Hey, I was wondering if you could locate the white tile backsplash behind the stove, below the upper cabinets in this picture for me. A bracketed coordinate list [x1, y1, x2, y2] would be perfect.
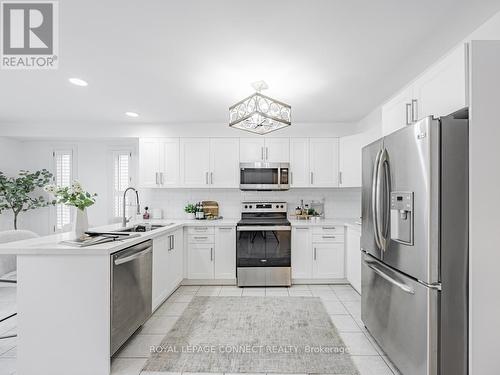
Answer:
[140, 188, 361, 219]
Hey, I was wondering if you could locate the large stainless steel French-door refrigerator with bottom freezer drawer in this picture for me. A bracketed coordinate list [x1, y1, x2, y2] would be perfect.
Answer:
[361, 109, 469, 375]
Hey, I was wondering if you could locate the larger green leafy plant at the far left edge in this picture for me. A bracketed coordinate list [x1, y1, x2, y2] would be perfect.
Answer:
[0, 169, 55, 229]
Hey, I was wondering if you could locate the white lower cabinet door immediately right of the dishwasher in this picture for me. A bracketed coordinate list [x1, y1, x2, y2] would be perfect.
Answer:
[152, 235, 170, 310]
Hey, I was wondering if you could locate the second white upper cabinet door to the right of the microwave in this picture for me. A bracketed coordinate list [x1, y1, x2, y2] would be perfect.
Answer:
[309, 138, 339, 187]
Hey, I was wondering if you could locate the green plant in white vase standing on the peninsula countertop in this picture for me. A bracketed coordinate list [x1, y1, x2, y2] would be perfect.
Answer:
[44, 180, 97, 238]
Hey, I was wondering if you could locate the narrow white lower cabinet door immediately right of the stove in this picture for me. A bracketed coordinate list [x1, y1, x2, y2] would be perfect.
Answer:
[292, 227, 313, 279]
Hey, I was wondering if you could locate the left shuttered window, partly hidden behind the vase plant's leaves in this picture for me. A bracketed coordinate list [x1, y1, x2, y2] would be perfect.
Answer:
[53, 150, 73, 232]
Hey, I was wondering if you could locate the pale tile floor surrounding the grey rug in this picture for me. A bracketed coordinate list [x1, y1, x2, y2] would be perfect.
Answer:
[0, 285, 399, 375]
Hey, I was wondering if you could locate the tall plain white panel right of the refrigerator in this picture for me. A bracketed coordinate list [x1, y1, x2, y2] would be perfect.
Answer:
[469, 39, 500, 374]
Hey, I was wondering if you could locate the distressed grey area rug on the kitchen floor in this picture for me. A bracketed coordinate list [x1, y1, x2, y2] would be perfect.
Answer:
[143, 297, 359, 375]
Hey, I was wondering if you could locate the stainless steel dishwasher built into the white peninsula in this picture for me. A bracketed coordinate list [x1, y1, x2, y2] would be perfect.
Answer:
[111, 240, 153, 355]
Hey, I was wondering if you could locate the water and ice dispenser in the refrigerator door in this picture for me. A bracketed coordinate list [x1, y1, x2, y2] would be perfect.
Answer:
[391, 191, 413, 245]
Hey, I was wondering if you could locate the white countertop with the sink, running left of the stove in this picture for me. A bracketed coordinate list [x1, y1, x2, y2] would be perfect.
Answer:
[0, 219, 239, 255]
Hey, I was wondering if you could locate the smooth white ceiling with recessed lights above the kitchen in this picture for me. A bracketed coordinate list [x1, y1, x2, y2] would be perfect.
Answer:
[0, 0, 500, 129]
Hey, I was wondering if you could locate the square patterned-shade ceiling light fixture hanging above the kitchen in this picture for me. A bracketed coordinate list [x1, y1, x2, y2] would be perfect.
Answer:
[229, 81, 292, 135]
